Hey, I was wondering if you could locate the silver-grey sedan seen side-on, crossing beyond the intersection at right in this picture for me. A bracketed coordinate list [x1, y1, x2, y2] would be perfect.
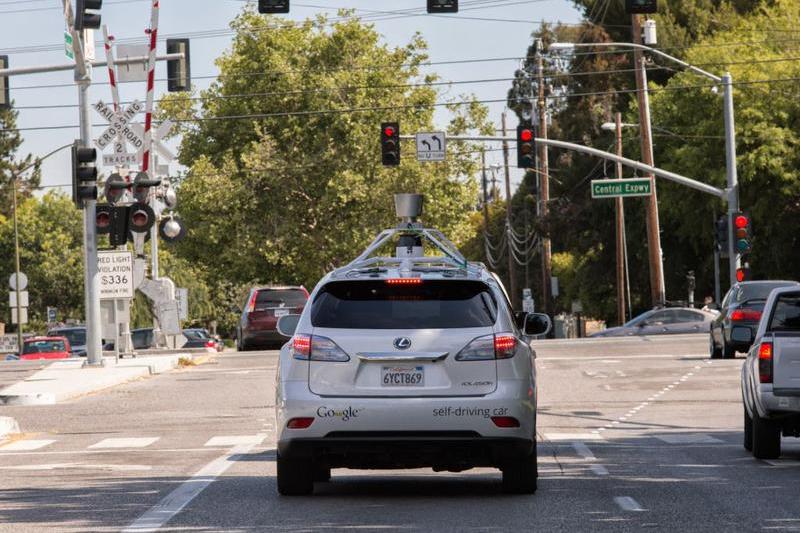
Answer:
[591, 307, 717, 337]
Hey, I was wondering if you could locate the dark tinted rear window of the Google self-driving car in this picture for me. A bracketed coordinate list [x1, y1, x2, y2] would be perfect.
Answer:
[311, 280, 497, 329]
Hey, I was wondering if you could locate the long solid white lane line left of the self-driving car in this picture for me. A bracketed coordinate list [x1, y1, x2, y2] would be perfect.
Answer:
[122, 435, 266, 533]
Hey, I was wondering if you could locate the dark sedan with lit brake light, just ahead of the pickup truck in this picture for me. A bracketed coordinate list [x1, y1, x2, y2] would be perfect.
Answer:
[709, 281, 798, 359]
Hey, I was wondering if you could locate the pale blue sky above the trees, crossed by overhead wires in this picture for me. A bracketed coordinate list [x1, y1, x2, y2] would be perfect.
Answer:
[0, 0, 580, 193]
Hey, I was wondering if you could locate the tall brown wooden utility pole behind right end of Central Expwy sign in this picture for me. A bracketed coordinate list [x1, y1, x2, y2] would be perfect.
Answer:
[631, 15, 666, 307]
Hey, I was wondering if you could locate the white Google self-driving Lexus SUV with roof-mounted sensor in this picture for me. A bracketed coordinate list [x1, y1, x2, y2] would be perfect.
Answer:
[276, 195, 550, 495]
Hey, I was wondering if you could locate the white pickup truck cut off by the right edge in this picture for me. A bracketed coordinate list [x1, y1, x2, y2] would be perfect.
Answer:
[742, 287, 800, 459]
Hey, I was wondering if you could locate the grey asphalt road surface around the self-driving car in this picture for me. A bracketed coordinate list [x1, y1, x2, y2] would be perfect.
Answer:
[0, 336, 800, 532]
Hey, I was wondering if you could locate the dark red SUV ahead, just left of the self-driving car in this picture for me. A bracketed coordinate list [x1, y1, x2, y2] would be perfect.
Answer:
[236, 286, 308, 351]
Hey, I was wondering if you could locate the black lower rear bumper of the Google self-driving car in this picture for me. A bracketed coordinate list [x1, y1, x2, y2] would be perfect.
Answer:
[278, 431, 534, 471]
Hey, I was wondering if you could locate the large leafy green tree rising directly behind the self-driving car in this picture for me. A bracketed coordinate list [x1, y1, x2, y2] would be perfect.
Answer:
[163, 8, 491, 287]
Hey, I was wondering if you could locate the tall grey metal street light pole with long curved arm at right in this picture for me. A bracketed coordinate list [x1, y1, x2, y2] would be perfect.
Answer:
[550, 43, 741, 285]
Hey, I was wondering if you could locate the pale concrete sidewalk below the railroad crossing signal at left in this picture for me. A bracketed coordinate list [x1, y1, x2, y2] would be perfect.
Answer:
[0, 353, 214, 405]
